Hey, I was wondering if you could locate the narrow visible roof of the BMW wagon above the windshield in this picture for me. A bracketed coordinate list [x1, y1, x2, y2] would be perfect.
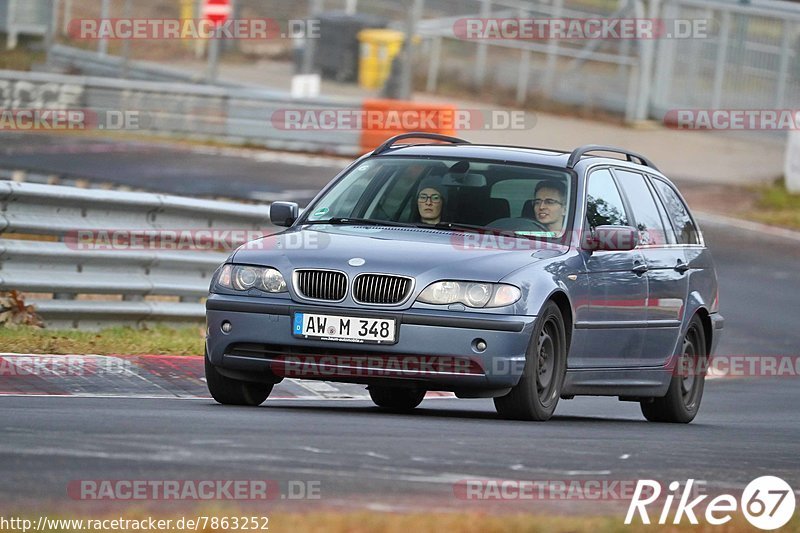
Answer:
[374, 143, 663, 176]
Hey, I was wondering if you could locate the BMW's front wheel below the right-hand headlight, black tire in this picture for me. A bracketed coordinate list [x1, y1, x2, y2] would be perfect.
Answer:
[494, 301, 567, 422]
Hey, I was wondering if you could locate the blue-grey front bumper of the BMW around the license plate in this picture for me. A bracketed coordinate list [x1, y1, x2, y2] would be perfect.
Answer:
[206, 294, 536, 392]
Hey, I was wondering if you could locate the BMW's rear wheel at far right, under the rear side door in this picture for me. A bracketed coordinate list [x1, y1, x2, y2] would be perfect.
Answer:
[640, 315, 708, 424]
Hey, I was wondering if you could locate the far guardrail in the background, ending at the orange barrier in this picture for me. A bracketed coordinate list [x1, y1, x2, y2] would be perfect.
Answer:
[0, 71, 363, 156]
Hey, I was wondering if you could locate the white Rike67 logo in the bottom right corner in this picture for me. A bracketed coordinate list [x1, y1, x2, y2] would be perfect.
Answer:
[625, 476, 796, 530]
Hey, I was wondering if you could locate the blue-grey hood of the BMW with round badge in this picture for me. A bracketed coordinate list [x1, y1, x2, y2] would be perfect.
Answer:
[233, 225, 568, 281]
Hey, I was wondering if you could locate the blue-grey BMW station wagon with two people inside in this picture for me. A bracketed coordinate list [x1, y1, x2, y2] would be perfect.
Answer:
[206, 133, 724, 423]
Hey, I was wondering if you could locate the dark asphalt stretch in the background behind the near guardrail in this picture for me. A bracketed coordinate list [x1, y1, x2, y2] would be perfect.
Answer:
[0, 133, 348, 203]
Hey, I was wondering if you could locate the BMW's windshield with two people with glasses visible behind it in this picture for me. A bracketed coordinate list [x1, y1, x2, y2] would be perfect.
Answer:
[301, 157, 573, 238]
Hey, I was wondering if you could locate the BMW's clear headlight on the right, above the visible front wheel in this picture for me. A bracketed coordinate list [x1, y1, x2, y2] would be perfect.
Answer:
[417, 281, 522, 307]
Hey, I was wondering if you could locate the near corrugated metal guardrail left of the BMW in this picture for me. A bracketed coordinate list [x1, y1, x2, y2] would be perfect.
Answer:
[0, 181, 274, 328]
